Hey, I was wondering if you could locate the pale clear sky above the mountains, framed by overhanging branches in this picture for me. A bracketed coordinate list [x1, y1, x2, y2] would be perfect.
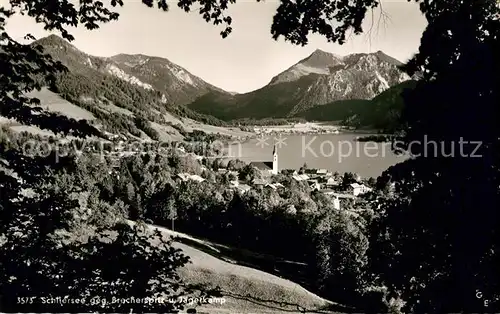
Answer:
[0, 0, 427, 93]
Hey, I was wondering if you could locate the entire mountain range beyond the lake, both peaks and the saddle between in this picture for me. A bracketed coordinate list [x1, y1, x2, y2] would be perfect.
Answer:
[1, 35, 410, 139]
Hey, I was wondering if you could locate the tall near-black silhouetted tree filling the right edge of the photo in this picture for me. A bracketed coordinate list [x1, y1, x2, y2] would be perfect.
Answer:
[370, 1, 500, 312]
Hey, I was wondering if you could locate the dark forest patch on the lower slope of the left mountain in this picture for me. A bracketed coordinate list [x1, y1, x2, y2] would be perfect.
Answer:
[50, 72, 226, 140]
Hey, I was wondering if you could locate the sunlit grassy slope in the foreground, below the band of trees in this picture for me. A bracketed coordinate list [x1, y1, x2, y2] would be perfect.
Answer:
[135, 221, 345, 313]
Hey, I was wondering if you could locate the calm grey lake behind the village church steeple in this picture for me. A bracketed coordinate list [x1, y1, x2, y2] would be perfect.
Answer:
[226, 133, 406, 177]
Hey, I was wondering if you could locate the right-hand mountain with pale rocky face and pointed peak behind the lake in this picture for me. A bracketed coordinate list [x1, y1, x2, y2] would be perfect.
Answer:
[188, 50, 410, 120]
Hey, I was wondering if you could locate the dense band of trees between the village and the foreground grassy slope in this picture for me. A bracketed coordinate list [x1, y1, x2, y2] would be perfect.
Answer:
[3, 130, 382, 312]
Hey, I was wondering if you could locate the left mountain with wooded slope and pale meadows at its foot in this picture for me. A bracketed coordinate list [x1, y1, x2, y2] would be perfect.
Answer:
[16, 35, 244, 140]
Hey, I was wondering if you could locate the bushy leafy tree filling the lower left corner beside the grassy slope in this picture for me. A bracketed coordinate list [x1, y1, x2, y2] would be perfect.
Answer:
[0, 143, 208, 312]
